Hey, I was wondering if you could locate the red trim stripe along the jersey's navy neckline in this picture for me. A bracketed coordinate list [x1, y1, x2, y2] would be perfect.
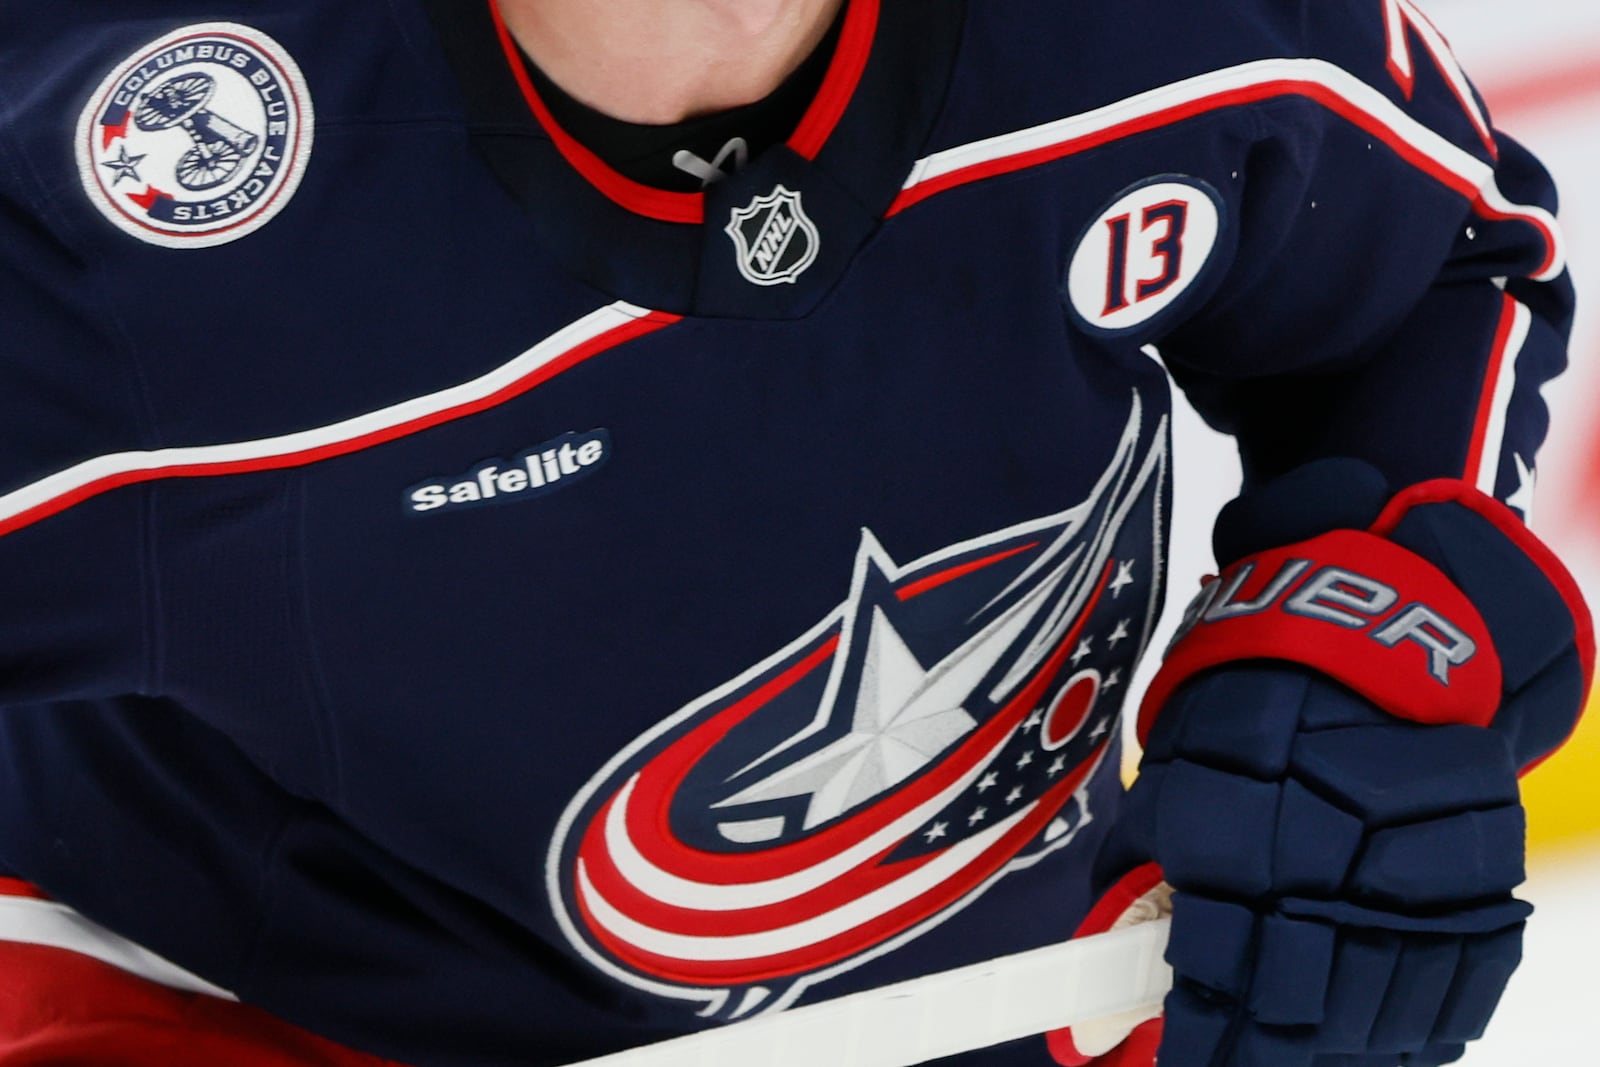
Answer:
[488, 0, 880, 224]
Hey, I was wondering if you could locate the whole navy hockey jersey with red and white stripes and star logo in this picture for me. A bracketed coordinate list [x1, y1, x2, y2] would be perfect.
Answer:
[0, 0, 1570, 1067]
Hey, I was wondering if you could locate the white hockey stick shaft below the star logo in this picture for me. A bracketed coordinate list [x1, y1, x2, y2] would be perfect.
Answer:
[571, 918, 1173, 1067]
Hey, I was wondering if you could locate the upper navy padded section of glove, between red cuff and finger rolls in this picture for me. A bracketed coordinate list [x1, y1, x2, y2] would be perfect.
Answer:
[1128, 664, 1525, 920]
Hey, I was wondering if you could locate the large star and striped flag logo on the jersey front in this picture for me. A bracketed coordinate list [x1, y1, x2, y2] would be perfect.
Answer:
[547, 391, 1166, 1019]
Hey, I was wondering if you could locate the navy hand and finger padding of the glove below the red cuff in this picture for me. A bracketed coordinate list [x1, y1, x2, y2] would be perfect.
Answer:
[1132, 664, 1531, 1067]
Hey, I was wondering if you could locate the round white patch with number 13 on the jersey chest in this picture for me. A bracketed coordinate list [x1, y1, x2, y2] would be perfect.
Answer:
[1066, 174, 1222, 331]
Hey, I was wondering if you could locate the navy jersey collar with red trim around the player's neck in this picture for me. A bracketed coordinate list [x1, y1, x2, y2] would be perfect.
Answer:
[422, 0, 965, 318]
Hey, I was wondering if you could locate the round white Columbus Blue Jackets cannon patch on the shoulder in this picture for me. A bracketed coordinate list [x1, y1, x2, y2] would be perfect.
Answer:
[77, 22, 314, 248]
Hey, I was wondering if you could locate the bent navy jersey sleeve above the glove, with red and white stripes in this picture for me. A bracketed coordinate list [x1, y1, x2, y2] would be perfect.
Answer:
[1160, 0, 1573, 512]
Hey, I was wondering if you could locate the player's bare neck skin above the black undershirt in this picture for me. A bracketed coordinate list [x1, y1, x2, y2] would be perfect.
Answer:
[499, 0, 845, 125]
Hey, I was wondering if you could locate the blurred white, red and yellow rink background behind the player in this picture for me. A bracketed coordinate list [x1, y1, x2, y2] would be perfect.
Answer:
[1146, 0, 1600, 1067]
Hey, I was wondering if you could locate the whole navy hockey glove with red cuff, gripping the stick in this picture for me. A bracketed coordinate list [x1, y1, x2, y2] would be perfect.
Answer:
[1053, 462, 1594, 1067]
